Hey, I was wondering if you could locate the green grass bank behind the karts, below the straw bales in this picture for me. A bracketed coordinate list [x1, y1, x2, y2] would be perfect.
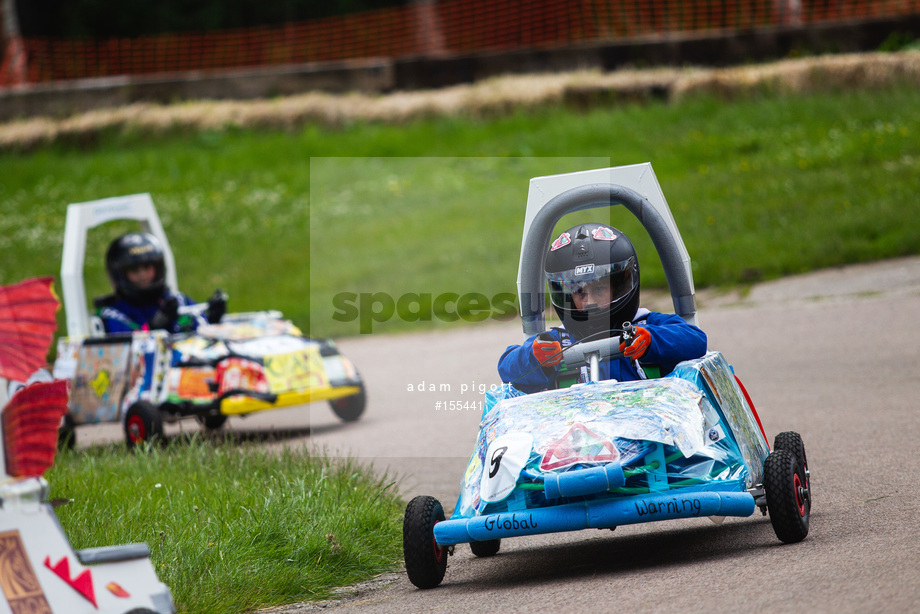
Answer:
[0, 85, 920, 336]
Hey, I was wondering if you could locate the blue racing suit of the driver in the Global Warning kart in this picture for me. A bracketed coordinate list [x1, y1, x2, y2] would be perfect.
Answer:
[498, 309, 706, 394]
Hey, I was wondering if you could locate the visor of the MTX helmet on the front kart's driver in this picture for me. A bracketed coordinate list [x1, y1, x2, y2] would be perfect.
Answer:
[546, 258, 639, 309]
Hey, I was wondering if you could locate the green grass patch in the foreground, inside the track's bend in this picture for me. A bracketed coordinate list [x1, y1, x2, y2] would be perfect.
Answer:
[46, 439, 403, 614]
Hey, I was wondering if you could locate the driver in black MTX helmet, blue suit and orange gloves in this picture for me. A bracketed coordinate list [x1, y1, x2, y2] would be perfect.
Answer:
[498, 224, 706, 393]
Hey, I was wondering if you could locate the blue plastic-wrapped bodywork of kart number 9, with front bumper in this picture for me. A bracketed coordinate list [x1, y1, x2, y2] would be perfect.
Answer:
[434, 352, 769, 545]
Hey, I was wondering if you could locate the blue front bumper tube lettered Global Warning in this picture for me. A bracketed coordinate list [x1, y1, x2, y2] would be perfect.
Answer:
[434, 489, 756, 546]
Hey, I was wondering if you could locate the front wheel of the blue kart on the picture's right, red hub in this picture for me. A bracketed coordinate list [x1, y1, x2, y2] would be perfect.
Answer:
[763, 449, 811, 544]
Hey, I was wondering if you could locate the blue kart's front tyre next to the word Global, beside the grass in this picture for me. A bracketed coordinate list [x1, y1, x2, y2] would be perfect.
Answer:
[403, 495, 447, 588]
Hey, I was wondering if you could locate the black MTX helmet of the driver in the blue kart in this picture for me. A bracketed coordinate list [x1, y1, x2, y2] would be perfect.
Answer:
[543, 223, 639, 339]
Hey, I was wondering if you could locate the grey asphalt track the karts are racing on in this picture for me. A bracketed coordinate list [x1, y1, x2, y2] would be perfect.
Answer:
[78, 258, 920, 614]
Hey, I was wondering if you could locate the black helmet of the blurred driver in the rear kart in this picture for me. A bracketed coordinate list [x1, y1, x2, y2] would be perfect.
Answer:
[105, 232, 166, 303]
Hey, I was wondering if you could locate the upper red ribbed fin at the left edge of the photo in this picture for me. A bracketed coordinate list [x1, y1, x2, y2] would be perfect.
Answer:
[0, 277, 58, 382]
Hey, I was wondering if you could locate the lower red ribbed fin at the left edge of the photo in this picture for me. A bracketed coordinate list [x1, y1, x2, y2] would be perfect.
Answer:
[2, 379, 70, 478]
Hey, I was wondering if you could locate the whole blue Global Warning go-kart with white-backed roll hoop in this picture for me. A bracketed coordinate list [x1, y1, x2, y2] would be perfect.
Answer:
[403, 164, 811, 588]
